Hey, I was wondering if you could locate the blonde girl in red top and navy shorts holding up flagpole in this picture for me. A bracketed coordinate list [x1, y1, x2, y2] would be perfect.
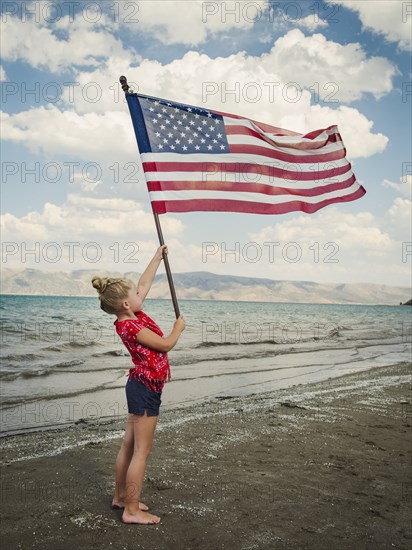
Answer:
[92, 245, 185, 524]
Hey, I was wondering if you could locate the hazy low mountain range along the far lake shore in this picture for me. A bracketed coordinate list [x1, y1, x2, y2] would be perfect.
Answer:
[0, 269, 411, 305]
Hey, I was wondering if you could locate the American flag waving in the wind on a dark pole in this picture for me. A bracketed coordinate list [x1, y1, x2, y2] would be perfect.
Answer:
[126, 93, 366, 214]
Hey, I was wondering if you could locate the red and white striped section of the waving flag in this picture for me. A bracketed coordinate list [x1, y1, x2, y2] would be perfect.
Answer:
[141, 113, 366, 214]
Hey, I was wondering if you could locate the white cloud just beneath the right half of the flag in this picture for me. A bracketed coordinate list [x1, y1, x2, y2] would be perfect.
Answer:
[232, 205, 406, 283]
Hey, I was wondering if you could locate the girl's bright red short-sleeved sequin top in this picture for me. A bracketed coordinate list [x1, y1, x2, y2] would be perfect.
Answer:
[114, 311, 170, 393]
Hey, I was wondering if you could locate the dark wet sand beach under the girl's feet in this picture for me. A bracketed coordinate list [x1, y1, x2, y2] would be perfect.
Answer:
[1, 363, 412, 550]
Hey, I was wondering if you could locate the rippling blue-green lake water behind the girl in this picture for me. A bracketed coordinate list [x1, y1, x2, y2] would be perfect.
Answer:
[0, 295, 412, 435]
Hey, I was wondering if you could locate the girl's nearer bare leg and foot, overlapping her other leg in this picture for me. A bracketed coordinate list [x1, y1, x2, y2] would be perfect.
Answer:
[122, 411, 160, 524]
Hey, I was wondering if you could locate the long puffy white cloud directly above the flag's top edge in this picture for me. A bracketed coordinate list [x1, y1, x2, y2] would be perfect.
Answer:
[64, 29, 397, 117]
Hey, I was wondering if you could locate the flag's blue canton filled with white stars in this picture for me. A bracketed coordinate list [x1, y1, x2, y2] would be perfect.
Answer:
[139, 97, 229, 154]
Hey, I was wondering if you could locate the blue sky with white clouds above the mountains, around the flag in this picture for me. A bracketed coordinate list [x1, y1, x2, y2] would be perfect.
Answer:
[0, 0, 412, 286]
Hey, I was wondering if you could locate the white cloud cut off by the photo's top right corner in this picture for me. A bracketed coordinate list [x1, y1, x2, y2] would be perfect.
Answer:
[337, 0, 412, 50]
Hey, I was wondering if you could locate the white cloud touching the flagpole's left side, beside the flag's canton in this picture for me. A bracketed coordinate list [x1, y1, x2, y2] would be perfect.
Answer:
[0, 105, 159, 204]
